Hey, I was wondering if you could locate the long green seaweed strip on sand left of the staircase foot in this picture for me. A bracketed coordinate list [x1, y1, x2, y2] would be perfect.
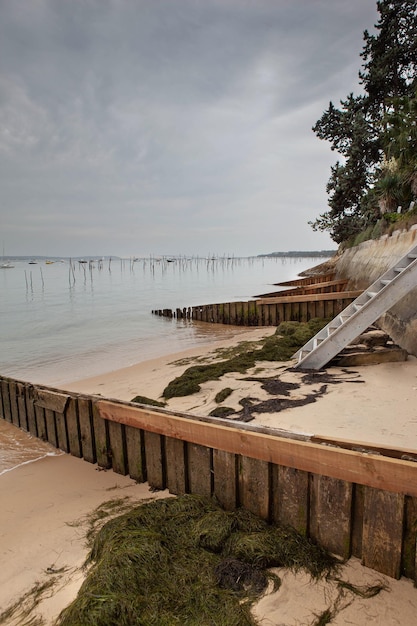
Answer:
[162, 318, 329, 400]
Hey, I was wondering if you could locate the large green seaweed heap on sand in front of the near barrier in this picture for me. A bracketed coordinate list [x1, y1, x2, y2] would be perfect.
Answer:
[57, 495, 338, 626]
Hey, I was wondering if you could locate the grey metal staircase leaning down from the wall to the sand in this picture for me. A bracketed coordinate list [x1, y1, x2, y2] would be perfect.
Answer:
[293, 245, 417, 370]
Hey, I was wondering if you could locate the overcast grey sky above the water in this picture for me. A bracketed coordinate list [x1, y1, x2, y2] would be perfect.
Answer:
[0, 0, 378, 256]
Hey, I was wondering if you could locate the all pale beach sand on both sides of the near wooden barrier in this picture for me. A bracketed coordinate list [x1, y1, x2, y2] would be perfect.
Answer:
[0, 328, 417, 626]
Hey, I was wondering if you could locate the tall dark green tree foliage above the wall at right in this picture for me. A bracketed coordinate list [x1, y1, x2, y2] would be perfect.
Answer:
[311, 0, 417, 243]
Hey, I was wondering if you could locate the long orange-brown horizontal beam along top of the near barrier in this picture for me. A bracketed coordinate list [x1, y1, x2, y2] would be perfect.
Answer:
[97, 400, 417, 496]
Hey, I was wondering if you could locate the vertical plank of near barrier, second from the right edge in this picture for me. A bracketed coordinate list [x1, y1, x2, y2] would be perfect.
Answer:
[362, 487, 404, 578]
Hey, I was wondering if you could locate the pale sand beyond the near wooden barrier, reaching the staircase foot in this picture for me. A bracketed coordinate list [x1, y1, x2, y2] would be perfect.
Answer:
[63, 327, 417, 452]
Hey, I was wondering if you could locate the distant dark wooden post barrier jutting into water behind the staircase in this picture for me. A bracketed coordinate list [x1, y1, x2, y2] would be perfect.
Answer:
[152, 291, 362, 326]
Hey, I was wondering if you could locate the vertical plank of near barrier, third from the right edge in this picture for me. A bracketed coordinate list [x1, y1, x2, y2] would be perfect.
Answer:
[310, 474, 352, 559]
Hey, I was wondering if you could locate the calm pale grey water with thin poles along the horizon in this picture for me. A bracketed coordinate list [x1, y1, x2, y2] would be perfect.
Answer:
[0, 258, 323, 386]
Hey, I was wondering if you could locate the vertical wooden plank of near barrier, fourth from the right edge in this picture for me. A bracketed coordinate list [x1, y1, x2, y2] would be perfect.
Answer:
[272, 465, 309, 535]
